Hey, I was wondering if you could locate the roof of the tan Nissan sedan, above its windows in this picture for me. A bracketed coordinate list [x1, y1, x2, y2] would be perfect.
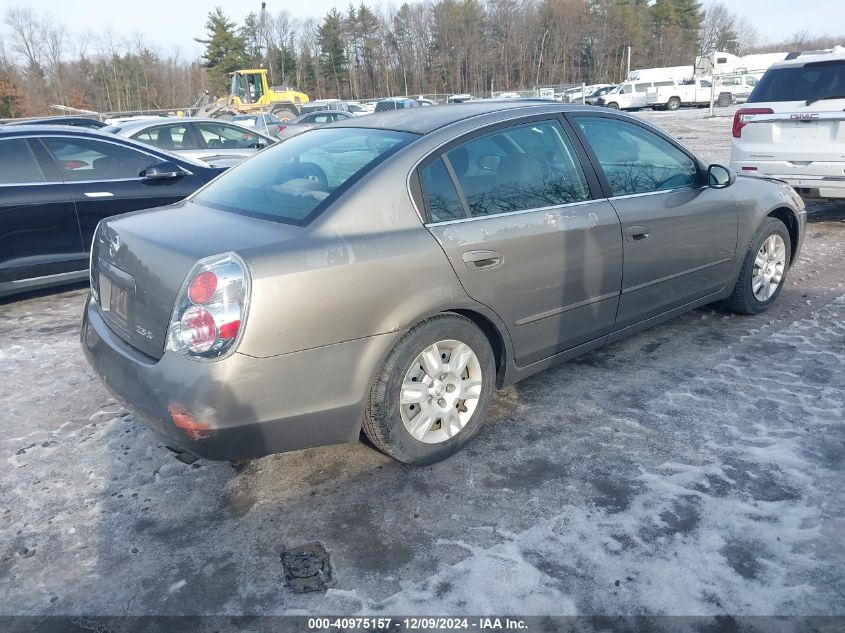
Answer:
[326, 99, 596, 134]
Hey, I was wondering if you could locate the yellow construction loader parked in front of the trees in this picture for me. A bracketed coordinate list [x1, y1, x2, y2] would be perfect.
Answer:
[196, 68, 309, 121]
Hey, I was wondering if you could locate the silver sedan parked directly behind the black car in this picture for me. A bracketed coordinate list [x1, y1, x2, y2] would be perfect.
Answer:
[102, 117, 276, 164]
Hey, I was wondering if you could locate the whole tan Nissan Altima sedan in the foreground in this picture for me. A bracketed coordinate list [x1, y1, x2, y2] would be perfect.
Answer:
[82, 101, 805, 464]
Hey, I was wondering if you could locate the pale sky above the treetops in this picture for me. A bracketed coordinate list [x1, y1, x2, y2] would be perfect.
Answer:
[0, 0, 845, 59]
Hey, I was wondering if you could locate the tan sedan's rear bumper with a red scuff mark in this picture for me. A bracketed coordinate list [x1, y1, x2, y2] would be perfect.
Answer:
[81, 300, 395, 460]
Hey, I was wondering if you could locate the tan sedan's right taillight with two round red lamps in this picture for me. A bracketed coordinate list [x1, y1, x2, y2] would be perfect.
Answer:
[166, 253, 250, 358]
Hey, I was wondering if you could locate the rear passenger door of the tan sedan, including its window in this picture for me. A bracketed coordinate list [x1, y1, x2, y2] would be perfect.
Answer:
[418, 118, 622, 366]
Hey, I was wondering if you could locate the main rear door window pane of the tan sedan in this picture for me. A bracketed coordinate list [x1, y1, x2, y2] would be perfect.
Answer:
[436, 121, 590, 216]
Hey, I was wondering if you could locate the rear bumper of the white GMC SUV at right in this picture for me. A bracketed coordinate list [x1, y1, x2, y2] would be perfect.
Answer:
[731, 159, 845, 198]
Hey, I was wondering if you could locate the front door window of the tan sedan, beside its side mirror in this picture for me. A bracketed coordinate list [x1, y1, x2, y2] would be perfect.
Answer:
[575, 117, 698, 196]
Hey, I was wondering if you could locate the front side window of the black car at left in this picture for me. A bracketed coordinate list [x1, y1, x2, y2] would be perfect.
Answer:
[43, 137, 161, 181]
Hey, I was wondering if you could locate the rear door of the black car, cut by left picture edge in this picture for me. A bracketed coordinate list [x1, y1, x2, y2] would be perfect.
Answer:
[0, 138, 88, 282]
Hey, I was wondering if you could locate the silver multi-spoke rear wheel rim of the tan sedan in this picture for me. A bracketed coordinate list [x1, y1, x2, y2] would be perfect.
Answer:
[399, 339, 481, 444]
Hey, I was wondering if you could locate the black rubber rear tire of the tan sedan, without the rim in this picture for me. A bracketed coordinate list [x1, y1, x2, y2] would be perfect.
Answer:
[363, 314, 496, 465]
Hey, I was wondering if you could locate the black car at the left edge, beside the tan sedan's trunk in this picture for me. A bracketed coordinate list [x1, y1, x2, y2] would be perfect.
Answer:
[0, 125, 224, 297]
